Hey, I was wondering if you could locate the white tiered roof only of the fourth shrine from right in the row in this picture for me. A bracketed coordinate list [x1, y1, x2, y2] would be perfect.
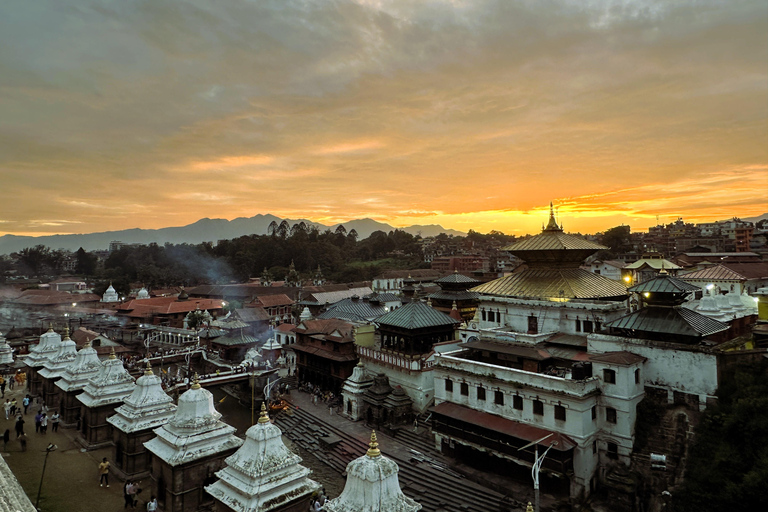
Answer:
[107, 362, 176, 433]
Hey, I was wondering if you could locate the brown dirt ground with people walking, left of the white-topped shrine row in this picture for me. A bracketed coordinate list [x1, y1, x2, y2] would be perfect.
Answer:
[0, 388, 138, 512]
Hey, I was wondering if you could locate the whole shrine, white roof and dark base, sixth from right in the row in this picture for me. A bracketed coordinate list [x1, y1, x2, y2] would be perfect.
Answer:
[55, 341, 101, 428]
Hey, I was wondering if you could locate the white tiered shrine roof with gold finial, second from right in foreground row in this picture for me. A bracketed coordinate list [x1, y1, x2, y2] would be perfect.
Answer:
[205, 403, 320, 512]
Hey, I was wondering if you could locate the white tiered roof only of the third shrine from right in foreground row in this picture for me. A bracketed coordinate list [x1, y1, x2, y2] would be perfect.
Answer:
[144, 376, 243, 466]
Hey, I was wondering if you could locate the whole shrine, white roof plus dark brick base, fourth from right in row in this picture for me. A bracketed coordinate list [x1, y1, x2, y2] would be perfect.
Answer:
[107, 362, 176, 480]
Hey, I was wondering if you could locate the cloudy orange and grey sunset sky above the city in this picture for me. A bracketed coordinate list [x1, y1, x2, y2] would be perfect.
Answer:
[0, 0, 768, 235]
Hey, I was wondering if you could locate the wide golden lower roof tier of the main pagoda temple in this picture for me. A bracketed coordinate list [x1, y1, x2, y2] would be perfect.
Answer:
[471, 268, 627, 299]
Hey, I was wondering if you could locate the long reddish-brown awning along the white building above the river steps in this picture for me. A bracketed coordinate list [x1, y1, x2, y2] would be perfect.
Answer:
[430, 402, 576, 452]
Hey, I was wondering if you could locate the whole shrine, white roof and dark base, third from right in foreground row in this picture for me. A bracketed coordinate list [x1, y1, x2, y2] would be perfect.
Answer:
[144, 376, 243, 512]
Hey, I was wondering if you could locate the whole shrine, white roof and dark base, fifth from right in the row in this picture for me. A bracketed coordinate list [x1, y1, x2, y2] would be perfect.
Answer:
[76, 349, 136, 450]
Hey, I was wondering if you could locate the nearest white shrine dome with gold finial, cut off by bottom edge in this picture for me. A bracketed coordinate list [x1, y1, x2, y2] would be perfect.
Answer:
[323, 432, 421, 512]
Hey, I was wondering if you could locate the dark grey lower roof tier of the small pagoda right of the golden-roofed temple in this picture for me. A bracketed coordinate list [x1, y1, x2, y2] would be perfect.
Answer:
[606, 307, 728, 338]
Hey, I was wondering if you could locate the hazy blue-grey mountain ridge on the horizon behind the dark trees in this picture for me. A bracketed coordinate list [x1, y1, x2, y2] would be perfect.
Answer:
[0, 214, 466, 254]
